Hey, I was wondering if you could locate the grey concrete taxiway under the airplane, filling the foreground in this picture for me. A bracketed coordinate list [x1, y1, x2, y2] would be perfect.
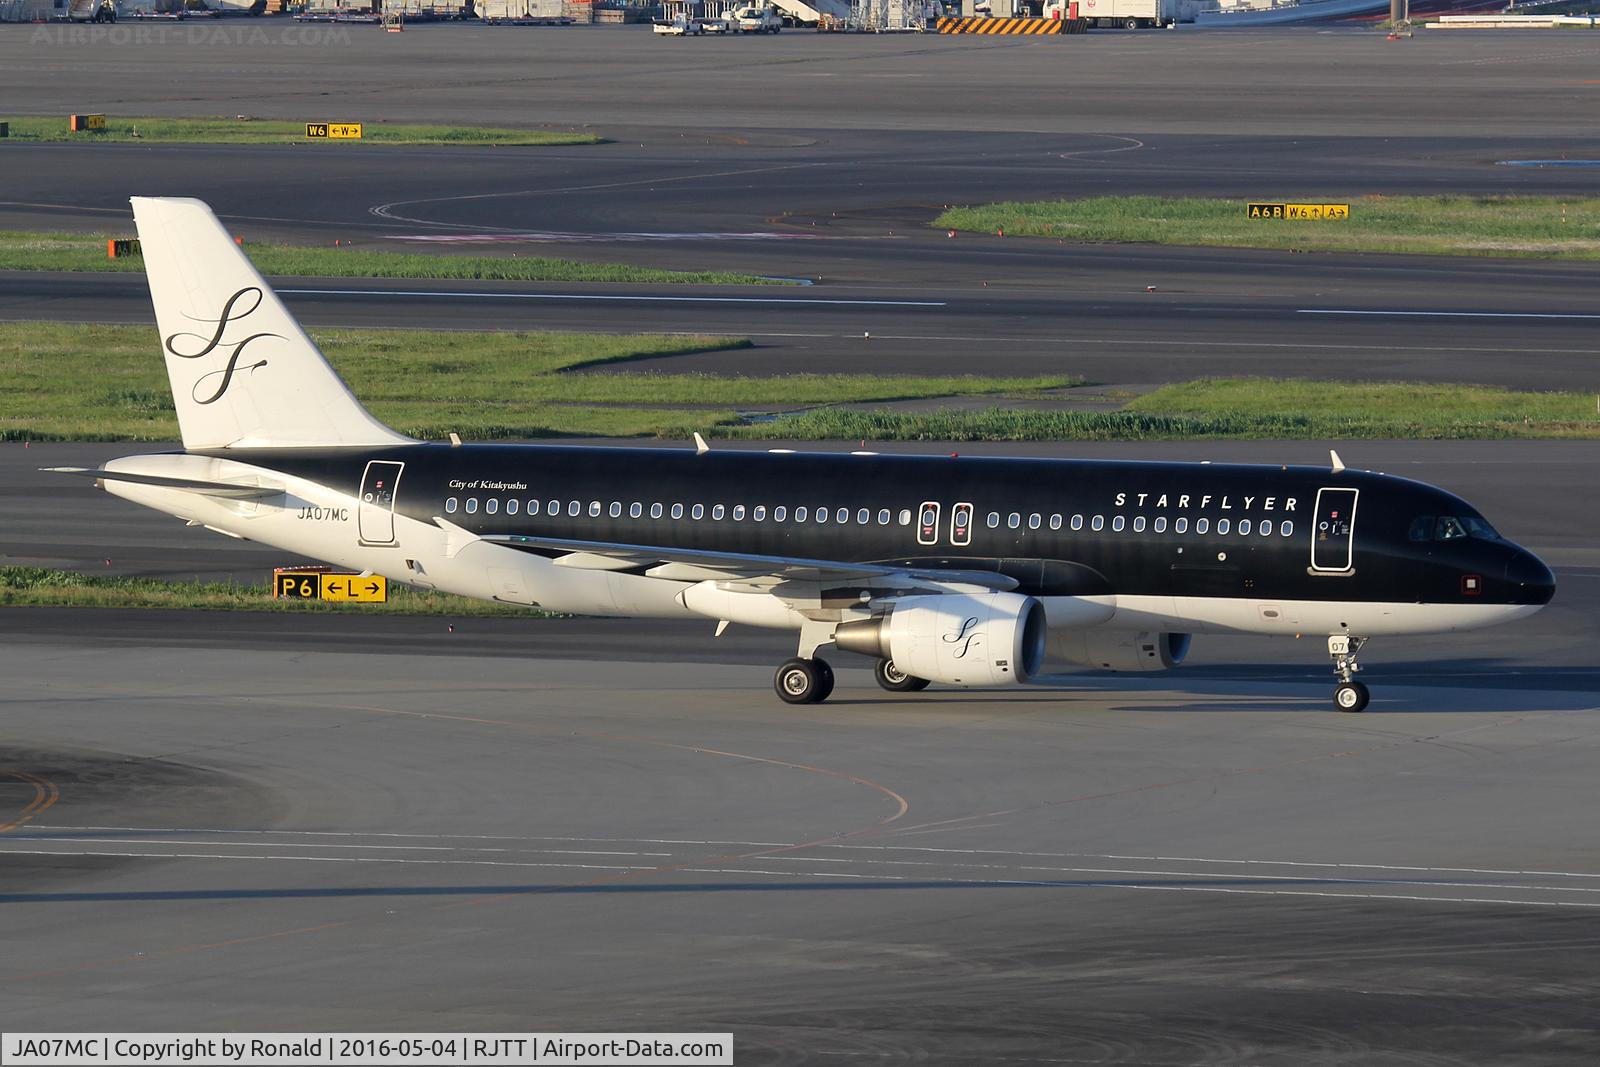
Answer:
[0, 442, 1600, 1064]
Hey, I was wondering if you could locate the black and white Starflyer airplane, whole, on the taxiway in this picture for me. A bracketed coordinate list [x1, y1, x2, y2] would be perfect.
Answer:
[53, 197, 1555, 712]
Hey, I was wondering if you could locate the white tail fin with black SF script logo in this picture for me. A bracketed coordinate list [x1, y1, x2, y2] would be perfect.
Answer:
[133, 197, 411, 448]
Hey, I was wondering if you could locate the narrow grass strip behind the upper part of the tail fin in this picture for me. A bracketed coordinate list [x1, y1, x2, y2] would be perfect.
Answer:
[0, 226, 789, 285]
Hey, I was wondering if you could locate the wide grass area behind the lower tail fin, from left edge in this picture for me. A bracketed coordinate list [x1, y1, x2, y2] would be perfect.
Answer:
[0, 323, 1080, 442]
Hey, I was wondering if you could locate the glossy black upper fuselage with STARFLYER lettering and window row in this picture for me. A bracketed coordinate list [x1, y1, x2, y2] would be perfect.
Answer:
[213, 445, 1554, 605]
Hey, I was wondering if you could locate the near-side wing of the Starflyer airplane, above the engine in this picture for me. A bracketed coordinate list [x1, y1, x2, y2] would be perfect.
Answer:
[476, 534, 1018, 590]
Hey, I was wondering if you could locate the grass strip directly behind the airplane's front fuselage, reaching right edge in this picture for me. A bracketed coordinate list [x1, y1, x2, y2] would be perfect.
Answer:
[732, 378, 1600, 442]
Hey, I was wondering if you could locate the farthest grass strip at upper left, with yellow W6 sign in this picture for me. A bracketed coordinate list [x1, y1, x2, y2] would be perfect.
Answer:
[0, 115, 602, 150]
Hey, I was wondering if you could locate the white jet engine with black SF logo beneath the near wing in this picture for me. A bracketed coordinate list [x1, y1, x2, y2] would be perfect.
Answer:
[834, 593, 1045, 685]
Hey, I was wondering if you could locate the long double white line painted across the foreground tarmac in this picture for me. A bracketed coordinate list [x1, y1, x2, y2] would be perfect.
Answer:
[15, 825, 1600, 907]
